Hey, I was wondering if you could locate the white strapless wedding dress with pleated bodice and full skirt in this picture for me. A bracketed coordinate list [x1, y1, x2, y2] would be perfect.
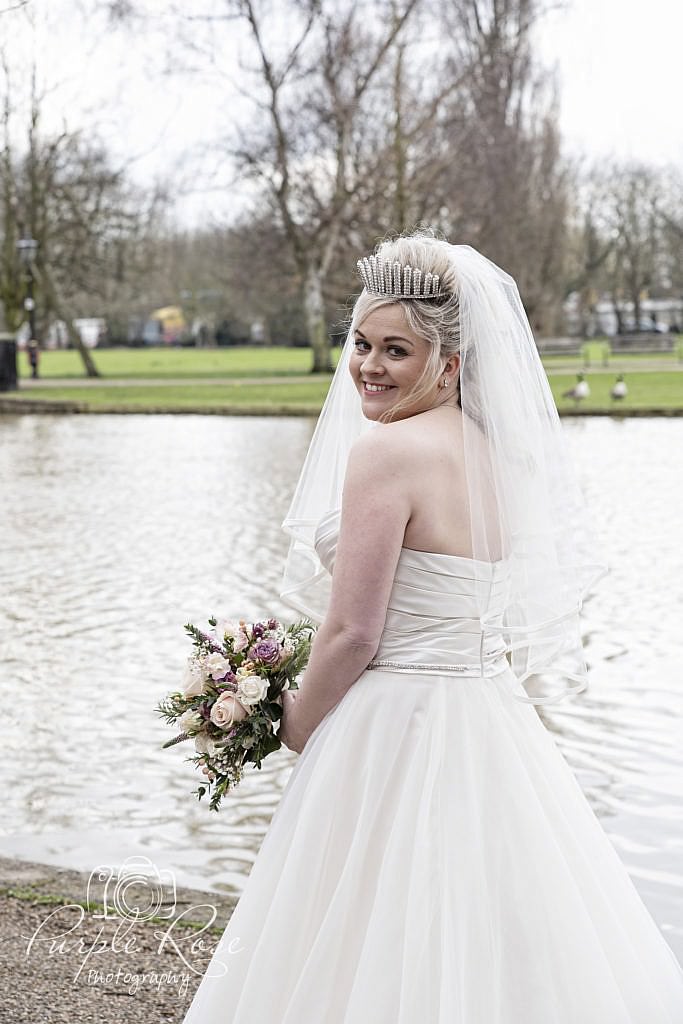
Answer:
[185, 511, 683, 1024]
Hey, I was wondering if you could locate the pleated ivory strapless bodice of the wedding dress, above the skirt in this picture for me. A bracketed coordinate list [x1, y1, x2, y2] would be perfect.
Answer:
[315, 509, 509, 677]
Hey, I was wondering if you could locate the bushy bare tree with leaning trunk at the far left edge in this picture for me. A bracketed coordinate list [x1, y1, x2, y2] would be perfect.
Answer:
[0, 50, 163, 377]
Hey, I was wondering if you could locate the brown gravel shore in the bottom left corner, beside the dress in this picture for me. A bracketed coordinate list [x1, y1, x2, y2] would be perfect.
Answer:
[0, 858, 240, 1024]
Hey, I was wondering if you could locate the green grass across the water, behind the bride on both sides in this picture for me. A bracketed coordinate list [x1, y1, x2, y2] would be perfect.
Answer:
[6, 348, 683, 416]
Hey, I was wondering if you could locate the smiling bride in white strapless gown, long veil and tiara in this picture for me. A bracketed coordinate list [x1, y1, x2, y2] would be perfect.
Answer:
[185, 232, 683, 1024]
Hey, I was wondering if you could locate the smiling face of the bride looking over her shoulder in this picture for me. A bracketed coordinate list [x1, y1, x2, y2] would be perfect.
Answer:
[349, 304, 446, 420]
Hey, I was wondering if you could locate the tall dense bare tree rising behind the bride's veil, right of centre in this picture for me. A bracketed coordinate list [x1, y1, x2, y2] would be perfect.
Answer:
[421, 0, 570, 331]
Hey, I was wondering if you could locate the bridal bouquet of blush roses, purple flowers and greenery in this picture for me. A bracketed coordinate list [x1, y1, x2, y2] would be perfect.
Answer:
[155, 617, 315, 811]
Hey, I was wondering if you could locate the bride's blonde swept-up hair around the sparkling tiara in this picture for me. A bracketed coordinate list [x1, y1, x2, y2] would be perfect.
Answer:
[351, 231, 460, 422]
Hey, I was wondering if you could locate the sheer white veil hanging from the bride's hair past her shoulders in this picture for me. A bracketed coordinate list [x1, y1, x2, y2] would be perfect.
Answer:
[281, 240, 607, 705]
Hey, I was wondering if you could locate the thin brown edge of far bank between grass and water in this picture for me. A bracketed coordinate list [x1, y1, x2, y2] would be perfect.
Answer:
[0, 395, 683, 420]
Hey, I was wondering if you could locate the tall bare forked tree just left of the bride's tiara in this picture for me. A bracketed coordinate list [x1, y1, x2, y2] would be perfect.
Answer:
[156, 0, 418, 373]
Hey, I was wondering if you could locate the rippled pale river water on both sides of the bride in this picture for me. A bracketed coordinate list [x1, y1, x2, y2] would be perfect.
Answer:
[0, 416, 683, 958]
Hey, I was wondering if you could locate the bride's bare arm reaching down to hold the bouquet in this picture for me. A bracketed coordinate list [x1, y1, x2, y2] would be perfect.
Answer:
[282, 427, 411, 752]
